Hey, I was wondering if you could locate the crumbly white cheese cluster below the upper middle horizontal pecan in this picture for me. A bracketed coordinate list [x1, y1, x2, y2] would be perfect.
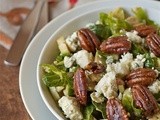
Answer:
[106, 53, 133, 75]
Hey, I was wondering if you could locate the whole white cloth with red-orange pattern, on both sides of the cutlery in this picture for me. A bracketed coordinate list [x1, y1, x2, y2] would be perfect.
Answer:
[0, 0, 94, 49]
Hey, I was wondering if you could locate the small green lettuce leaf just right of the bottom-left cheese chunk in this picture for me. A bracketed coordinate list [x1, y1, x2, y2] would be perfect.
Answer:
[83, 104, 95, 120]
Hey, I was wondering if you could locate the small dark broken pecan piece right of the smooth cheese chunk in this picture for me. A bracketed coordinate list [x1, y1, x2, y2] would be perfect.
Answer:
[85, 62, 105, 74]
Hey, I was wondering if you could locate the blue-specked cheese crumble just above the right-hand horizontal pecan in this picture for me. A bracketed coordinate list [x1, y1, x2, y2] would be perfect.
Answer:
[131, 54, 146, 70]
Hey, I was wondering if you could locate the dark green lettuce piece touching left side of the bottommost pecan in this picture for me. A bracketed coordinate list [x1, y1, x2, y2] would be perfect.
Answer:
[92, 101, 107, 119]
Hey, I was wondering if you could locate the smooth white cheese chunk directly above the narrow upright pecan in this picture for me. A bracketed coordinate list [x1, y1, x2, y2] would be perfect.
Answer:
[73, 50, 93, 68]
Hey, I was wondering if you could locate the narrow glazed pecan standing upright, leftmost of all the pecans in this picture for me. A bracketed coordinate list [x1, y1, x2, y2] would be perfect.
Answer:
[73, 68, 87, 105]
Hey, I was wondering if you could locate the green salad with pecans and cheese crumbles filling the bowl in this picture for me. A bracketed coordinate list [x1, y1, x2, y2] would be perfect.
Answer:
[41, 7, 160, 120]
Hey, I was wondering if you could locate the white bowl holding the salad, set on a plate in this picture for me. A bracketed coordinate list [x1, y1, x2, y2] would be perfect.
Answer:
[37, 0, 160, 119]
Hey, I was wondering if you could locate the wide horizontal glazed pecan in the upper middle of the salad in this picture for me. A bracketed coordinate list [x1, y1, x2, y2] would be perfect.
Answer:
[100, 36, 131, 54]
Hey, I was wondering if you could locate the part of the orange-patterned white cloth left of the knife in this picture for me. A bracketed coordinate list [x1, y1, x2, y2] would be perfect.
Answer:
[0, 0, 35, 49]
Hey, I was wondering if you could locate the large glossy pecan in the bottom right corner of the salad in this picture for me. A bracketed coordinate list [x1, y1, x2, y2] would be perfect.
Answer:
[131, 85, 159, 116]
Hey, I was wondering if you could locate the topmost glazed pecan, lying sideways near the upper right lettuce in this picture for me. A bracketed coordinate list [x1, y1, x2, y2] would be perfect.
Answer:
[135, 24, 156, 37]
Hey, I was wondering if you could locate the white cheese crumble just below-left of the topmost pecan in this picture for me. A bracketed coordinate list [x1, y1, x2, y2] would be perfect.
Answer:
[126, 30, 144, 43]
